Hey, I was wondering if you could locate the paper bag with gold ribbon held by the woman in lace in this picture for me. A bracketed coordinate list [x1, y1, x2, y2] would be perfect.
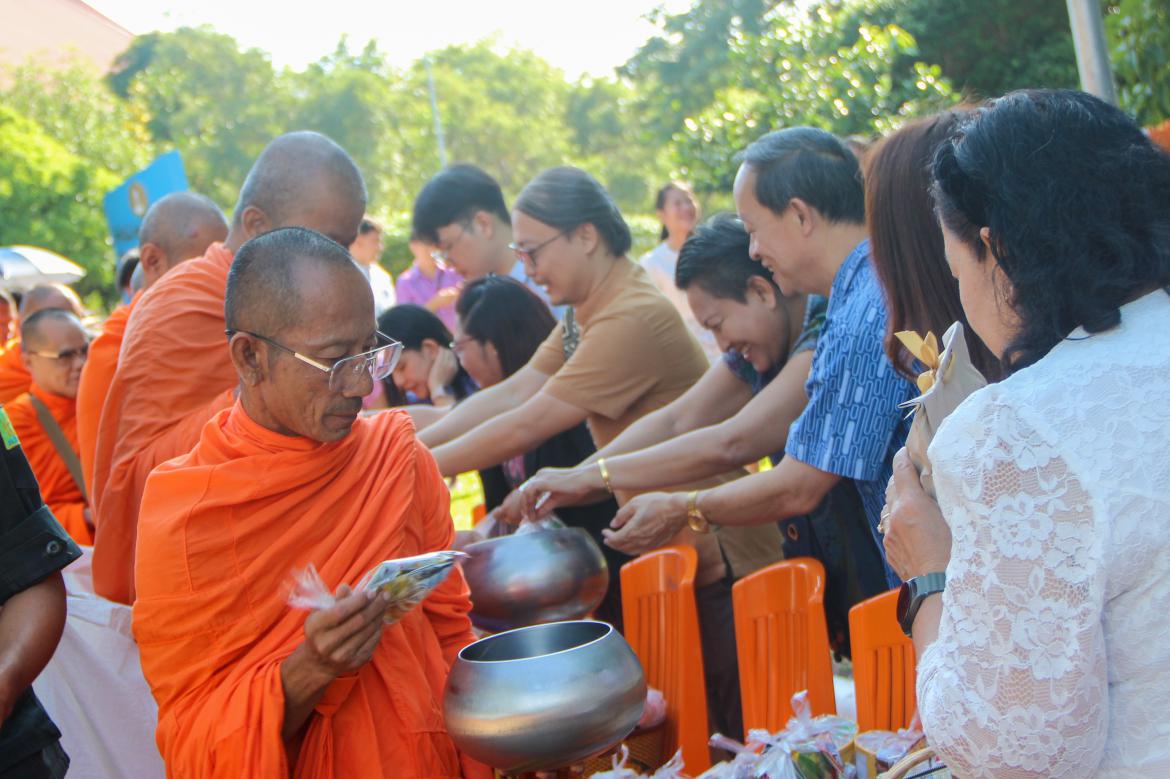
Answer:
[895, 322, 987, 497]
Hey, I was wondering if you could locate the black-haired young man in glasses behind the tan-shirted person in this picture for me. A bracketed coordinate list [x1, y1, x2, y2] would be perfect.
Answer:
[412, 163, 565, 319]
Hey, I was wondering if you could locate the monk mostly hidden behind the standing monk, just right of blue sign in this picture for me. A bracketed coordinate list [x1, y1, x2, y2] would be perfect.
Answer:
[77, 192, 227, 488]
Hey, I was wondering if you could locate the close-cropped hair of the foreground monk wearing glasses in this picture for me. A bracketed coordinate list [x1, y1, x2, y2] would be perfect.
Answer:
[223, 227, 360, 336]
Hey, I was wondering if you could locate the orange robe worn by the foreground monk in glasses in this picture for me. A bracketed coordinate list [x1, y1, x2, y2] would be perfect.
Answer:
[133, 404, 490, 779]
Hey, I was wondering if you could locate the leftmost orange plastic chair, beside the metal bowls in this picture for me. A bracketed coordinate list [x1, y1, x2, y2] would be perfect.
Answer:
[621, 546, 711, 775]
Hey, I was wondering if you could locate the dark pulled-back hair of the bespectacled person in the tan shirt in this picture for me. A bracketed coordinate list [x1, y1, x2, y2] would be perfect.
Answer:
[515, 166, 633, 257]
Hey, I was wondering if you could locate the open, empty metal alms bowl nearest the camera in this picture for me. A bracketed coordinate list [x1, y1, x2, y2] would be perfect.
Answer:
[443, 620, 646, 773]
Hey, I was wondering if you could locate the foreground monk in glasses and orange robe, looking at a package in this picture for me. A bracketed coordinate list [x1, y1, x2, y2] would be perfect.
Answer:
[133, 228, 490, 779]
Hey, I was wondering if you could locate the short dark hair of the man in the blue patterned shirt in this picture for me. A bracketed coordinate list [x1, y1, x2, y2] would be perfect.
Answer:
[738, 127, 866, 223]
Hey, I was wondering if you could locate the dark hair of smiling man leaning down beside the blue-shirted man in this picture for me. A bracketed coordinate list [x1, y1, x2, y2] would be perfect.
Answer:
[674, 214, 782, 303]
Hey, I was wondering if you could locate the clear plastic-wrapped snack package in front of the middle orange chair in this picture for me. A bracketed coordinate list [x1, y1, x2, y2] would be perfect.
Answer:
[748, 690, 858, 779]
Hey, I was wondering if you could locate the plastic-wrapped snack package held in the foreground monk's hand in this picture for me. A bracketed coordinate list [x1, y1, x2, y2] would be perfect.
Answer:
[288, 551, 467, 625]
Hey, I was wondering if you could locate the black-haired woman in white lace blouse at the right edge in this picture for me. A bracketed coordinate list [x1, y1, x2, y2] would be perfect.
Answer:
[886, 91, 1170, 778]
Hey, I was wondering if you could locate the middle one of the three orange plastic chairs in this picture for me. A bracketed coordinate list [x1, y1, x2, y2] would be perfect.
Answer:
[731, 557, 837, 732]
